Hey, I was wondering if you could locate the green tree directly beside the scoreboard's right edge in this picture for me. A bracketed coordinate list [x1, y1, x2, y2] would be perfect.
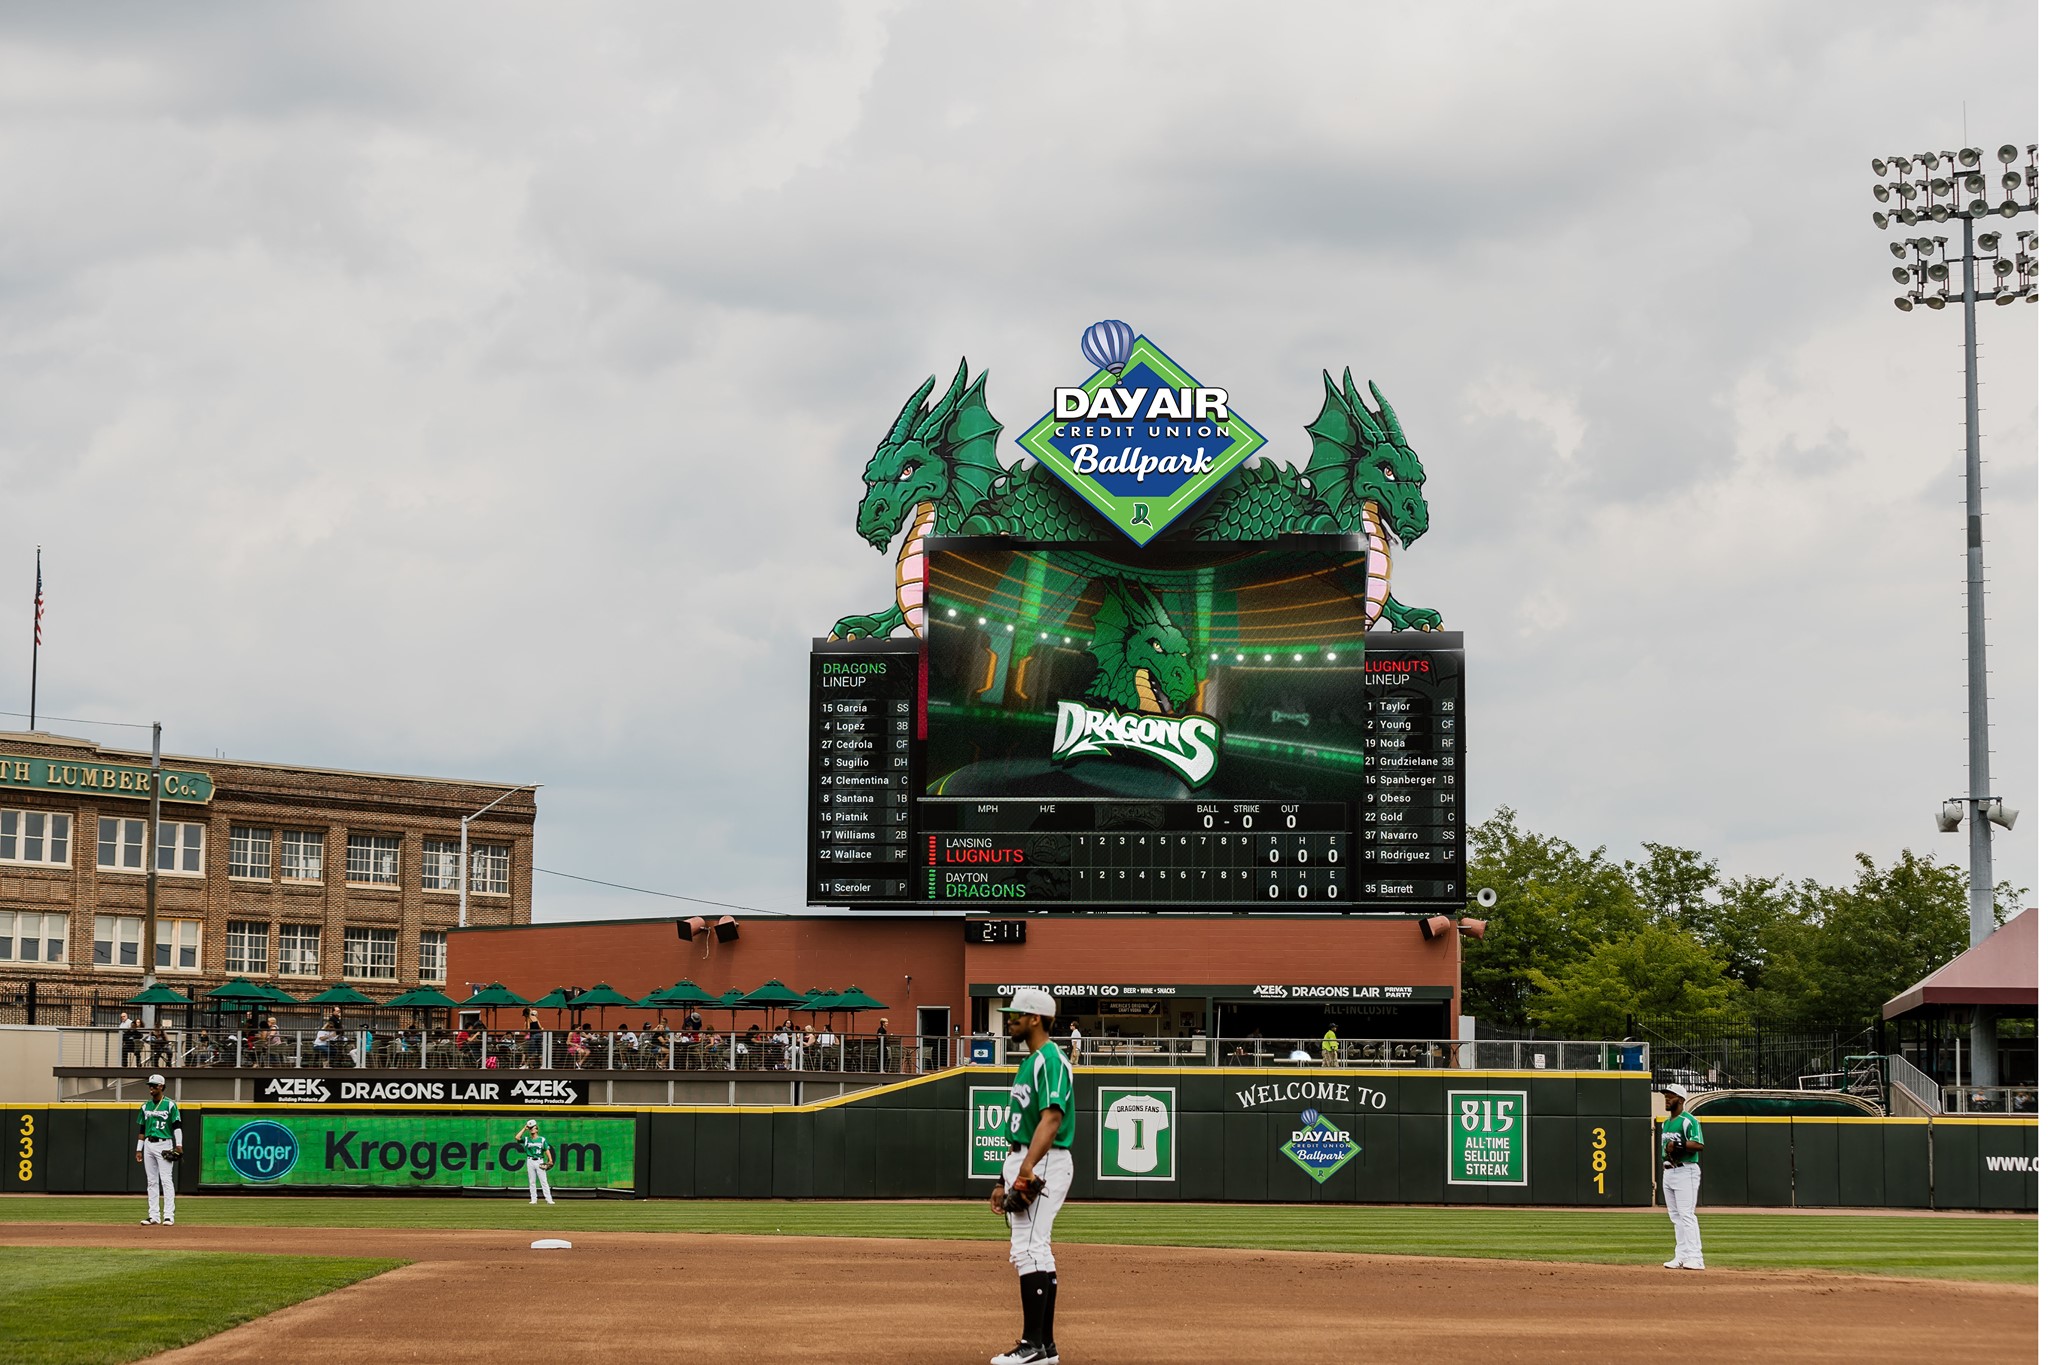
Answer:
[1464, 806, 1645, 1027]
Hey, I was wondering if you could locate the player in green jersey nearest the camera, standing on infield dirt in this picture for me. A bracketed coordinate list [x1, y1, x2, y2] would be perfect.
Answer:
[989, 986, 1073, 1365]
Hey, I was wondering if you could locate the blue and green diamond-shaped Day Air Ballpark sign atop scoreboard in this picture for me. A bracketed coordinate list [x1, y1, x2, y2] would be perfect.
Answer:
[1018, 336, 1266, 544]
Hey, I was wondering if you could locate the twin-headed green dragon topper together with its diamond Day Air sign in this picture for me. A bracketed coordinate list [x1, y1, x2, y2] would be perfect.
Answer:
[831, 323, 1444, 641]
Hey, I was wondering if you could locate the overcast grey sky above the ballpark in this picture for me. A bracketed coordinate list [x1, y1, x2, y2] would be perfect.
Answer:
[0, 0, 2048, 919]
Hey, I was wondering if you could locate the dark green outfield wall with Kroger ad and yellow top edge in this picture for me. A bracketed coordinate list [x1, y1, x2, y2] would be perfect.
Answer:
[0, 1068, 2038, 1209]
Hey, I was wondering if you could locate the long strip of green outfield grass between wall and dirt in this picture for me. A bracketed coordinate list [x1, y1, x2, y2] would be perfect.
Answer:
[0, 1195, 2040, 1283]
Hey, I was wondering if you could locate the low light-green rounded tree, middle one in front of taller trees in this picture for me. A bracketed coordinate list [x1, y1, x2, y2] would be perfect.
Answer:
[1530, 925, 1749, 1038]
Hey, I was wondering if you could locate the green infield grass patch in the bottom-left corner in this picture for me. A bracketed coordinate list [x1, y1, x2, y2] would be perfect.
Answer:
[0, 1252, 403, 1365]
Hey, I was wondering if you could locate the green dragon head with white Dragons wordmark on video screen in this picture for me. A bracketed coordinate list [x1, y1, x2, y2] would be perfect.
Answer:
[1053, 579, 1223, 786]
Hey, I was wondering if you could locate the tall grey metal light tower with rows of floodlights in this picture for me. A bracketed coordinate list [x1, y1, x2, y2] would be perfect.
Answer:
[1870, 143, 2040, 1085]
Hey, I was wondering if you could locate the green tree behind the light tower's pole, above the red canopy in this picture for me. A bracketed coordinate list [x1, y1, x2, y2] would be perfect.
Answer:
[1757, 849, 1970, 1031]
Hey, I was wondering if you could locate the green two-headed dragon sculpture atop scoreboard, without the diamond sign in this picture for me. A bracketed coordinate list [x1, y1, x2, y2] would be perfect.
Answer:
[831, 360, 1444, 641]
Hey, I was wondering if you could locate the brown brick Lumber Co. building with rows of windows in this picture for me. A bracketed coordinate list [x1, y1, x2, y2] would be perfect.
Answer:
[0, 733, 535, 1023]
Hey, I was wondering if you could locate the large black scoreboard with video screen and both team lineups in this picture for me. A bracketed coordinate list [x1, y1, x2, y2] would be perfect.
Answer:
[807, 534, 1464, 913]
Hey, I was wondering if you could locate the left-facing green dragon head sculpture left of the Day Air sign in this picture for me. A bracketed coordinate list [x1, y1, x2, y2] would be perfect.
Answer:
[854, 360, 1004, 551]
